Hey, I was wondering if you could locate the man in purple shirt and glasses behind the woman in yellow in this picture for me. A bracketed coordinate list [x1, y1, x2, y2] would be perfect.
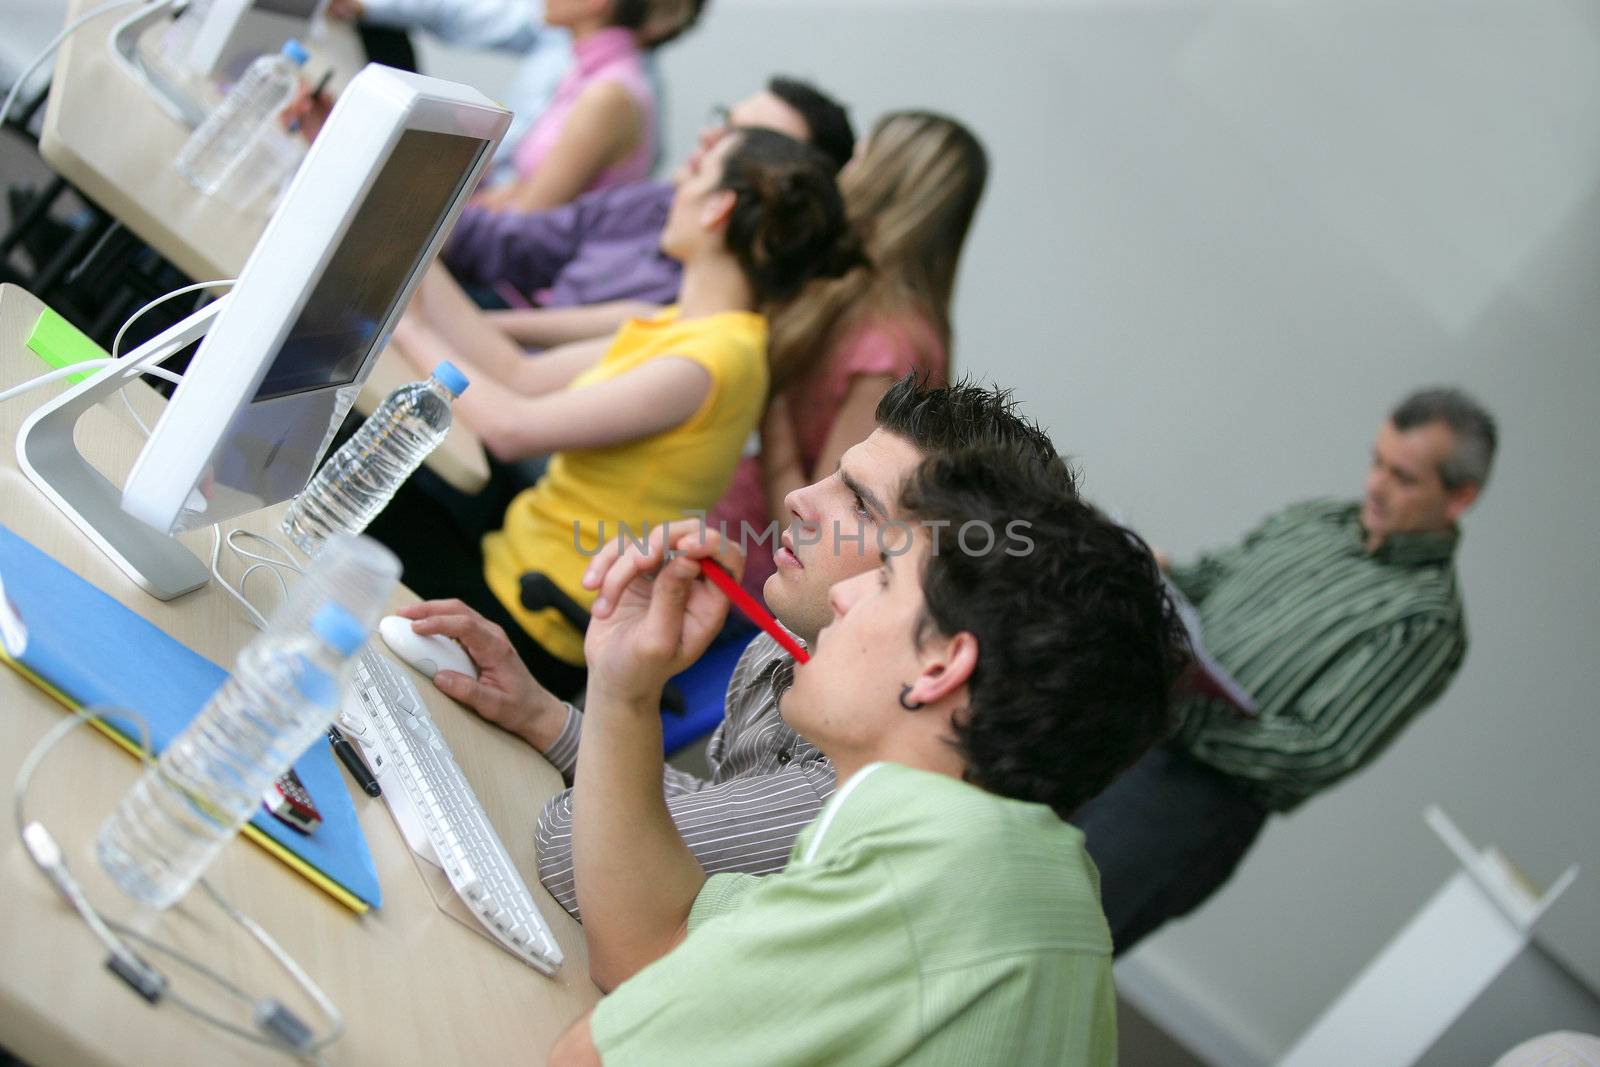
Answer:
[443, 77, 856, 315]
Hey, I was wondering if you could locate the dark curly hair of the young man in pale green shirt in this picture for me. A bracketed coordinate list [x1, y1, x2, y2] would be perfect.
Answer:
[901, 445, 1189, 819]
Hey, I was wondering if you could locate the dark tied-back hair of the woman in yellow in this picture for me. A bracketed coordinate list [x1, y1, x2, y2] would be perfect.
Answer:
[722, 130, 866, 304]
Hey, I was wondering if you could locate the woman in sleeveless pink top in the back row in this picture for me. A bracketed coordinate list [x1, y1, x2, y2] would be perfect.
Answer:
[477, 0, 704, 211]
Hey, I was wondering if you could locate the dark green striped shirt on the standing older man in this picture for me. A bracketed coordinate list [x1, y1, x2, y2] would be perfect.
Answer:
[1171, 501, 1467, 811]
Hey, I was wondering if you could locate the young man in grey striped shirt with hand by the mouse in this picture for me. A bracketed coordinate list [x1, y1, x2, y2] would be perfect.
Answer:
[402, 376, 1059, 915]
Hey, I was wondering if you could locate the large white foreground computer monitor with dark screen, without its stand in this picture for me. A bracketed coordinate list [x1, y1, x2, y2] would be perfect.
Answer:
[122, 66, 510, 533]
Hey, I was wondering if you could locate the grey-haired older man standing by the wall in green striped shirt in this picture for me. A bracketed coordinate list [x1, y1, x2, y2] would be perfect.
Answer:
[1074, 389, 1496, 953]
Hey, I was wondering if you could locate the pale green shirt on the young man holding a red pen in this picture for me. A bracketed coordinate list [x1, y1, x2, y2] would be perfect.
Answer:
[590, 763, 1117, 1067]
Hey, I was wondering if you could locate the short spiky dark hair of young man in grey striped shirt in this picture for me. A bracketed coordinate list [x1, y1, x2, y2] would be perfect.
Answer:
[875, 371, 1075, 476]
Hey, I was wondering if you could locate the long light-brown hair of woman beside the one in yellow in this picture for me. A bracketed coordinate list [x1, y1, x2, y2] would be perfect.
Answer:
[770, 110, 989, 394]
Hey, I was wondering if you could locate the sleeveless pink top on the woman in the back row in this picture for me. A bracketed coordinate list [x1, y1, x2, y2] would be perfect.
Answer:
[512, 26, 656, 192]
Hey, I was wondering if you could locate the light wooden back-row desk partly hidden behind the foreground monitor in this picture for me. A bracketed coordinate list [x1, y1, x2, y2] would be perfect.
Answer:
[38, 0, 488, 493]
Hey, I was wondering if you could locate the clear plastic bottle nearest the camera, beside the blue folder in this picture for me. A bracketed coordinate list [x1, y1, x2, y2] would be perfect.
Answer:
[94, 603, 370, 909]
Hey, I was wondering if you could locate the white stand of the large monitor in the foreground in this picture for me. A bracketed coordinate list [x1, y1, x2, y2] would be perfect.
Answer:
[16, 296, 227, 600]
